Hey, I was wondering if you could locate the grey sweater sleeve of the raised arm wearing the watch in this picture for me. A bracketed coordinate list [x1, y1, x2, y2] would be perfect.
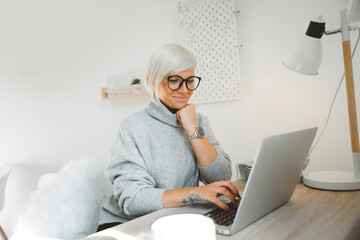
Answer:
[198, 116, 232, 184]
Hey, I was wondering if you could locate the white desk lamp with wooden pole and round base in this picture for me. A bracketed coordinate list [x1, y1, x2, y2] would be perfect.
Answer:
[284, 0, 360, 190]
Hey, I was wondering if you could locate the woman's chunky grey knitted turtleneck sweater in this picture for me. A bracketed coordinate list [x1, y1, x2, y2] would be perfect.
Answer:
[99, 98, 231, 224]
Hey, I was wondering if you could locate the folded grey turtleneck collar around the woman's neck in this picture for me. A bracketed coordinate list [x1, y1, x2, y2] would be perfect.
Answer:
[145, 95, 180, 127]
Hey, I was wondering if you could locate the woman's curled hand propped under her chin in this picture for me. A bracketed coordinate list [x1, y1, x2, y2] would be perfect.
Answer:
[176, 104, 197, 136]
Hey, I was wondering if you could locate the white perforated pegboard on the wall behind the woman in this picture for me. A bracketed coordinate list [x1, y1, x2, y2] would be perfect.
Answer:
[179, 0, 240, 103]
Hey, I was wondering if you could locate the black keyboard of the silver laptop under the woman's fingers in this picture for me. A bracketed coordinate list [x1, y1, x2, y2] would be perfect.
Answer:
[204, 202, 239, 226]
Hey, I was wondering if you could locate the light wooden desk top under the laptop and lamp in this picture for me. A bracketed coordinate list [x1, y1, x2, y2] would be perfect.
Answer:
[85, 181, 360, 240]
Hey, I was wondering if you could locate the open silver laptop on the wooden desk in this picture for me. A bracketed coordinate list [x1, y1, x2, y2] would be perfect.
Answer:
[168, 127, 317, 235]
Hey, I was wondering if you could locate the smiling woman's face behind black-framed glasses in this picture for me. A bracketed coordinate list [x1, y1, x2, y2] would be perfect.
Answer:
[158, 69, 194, 109]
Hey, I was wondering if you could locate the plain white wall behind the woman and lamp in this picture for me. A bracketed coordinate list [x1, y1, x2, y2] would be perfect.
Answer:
[0, 0, 360, 235]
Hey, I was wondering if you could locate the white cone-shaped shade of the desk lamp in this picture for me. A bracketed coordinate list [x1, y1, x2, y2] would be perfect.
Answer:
[284, 35, 322, 75]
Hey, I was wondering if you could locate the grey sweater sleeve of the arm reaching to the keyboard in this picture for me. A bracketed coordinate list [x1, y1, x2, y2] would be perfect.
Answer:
[106, 121, 165, 216]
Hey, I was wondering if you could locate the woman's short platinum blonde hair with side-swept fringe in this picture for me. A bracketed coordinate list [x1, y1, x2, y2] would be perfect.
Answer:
[145, 43, 196, 97]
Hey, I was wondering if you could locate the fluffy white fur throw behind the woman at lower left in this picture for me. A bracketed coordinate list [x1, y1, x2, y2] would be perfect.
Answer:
[11, 157, 111, 240]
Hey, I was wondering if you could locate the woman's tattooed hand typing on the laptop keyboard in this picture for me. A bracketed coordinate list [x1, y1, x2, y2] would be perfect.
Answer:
[180, 181, 240, 210]
